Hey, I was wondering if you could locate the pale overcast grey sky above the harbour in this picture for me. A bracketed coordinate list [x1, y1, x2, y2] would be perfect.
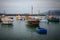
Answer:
[0, 0, 60, 14]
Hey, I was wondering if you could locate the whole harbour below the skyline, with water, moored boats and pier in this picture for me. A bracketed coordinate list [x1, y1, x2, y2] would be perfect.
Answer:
[0, 10, 60, 40]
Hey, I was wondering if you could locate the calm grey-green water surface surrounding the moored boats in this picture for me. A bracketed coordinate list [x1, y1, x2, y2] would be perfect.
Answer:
[0, 17, 60, 40]
